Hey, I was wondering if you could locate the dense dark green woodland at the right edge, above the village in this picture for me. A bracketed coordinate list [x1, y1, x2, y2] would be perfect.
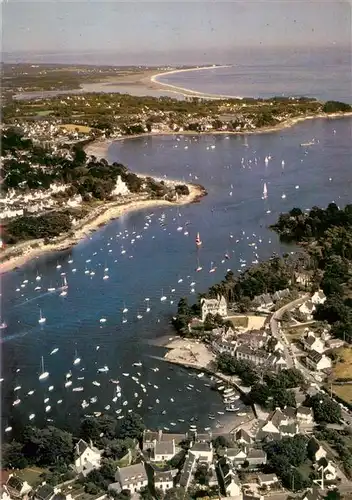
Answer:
[272, 203, 352, 342]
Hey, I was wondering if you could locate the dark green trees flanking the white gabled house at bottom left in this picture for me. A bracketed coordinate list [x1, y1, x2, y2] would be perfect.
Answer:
[1, 414, 145, 493]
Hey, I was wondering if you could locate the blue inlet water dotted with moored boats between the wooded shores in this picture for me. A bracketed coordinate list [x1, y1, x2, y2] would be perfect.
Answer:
[1, 118, 352, 436]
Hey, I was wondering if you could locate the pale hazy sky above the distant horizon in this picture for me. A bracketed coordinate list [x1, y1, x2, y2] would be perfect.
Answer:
[2, 0, 352, 64]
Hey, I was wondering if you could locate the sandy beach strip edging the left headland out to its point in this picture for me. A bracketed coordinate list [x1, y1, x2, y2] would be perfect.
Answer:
[0, 183, 206, 274]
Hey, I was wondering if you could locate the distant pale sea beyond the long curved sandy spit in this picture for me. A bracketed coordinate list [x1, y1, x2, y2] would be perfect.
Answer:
[158, 47, 352, 103]
